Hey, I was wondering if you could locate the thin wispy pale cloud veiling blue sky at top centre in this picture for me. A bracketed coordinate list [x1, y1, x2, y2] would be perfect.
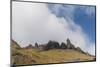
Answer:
[48, 4, 76, 19]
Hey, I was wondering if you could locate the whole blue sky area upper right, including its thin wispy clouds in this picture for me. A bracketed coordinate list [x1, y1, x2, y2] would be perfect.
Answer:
[48, 4, 96, 45]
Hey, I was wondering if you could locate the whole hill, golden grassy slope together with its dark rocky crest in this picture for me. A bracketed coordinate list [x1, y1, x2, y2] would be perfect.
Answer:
[11, 39, 95, 65]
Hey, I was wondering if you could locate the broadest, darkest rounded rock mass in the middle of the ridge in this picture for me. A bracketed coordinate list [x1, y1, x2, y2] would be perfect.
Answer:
[45, 41, 60, 50]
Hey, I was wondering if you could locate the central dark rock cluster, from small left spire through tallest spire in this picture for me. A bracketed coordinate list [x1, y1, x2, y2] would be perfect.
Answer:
[35, 39, 75, 50]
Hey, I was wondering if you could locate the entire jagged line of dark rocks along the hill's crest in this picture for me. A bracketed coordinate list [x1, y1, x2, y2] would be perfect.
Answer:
[18, 39, 84, 53]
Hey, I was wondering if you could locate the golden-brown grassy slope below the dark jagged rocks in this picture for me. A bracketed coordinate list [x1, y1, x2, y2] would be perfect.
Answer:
[11, 41, 95, 65]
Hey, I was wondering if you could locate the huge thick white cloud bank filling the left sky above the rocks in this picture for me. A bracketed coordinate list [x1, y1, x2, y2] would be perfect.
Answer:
[12, 2, 95, 55]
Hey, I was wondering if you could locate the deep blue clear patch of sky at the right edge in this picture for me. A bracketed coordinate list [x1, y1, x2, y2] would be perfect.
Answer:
[74, 6, 95, 42]
